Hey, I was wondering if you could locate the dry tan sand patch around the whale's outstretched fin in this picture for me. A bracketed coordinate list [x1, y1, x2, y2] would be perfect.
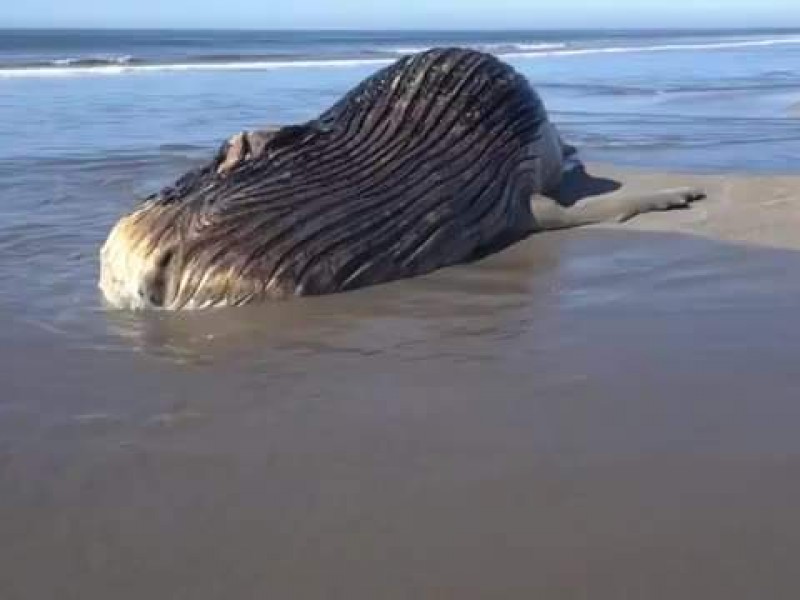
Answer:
[588, 165, 800, 249]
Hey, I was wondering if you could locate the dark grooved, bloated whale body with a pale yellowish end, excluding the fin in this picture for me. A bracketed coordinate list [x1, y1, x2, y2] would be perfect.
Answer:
[100, 49, 700, 309]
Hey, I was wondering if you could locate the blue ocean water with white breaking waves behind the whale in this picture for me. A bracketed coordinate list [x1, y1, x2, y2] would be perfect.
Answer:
[0, 30, 800, 166]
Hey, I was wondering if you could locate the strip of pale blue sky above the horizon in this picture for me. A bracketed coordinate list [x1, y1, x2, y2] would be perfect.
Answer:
[0, 0, 800, 29]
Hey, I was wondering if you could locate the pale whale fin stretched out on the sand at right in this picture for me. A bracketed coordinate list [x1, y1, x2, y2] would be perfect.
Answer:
[531, 187, 706, 230]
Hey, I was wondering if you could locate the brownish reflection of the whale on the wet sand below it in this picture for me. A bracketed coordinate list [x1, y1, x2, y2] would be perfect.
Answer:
[100, 227, 559, 362]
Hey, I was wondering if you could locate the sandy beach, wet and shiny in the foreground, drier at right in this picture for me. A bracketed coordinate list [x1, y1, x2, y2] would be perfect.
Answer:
[0, 167, 800, 600]
